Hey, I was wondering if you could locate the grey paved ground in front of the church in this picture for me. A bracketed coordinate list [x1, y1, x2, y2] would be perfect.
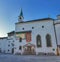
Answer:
[0, 55, 60, 62]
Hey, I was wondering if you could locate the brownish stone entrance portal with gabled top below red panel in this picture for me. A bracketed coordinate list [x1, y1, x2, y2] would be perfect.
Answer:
[23, 43, 36, 55]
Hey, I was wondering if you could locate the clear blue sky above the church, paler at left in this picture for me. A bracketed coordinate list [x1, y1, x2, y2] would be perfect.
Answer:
[0, 0, 60, 37]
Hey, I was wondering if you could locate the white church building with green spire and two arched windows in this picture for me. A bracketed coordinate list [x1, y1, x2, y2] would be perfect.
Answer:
[0, 11, 60, 55]
